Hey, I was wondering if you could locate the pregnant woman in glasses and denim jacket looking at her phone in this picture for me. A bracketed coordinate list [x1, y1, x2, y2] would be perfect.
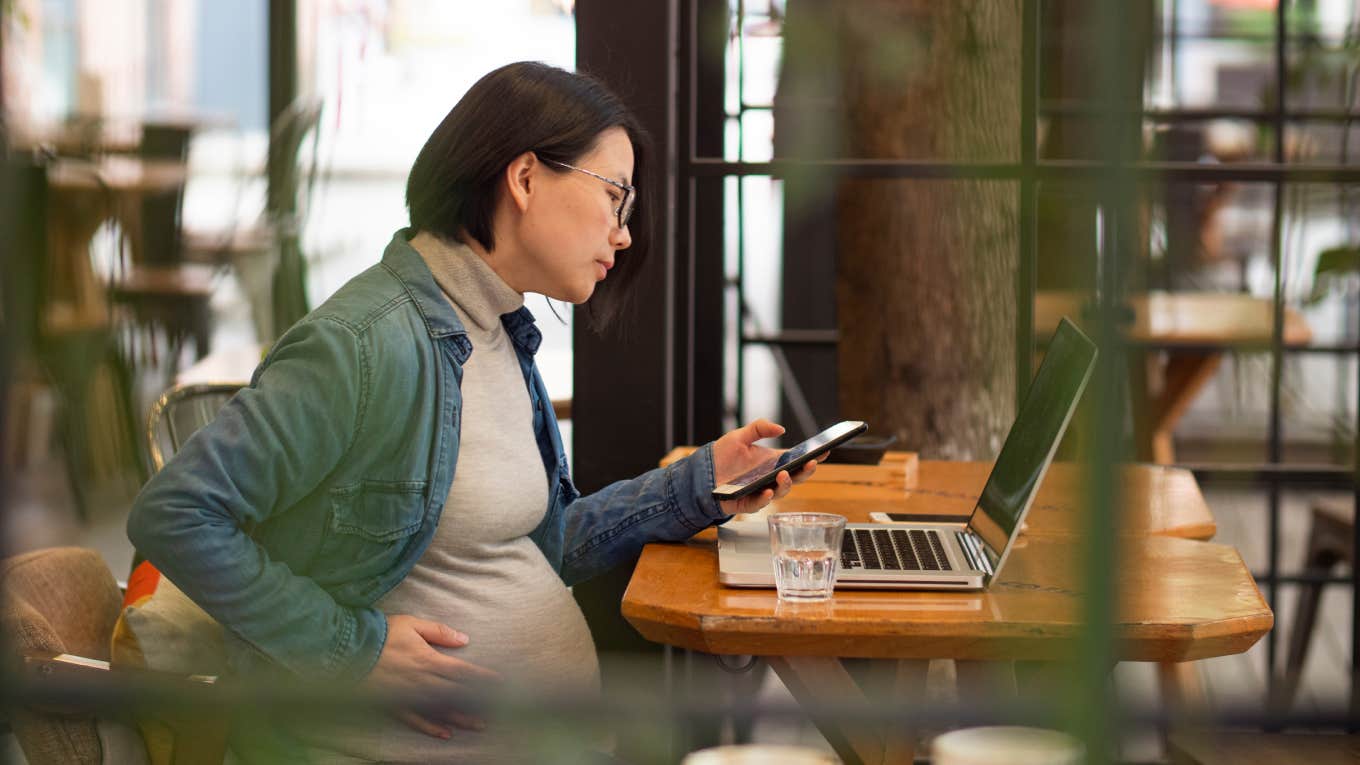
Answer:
[128, 63, 815, 762]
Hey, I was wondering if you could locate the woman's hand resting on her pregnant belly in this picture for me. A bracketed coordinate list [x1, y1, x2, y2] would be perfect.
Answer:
[366, 614, 500, 739]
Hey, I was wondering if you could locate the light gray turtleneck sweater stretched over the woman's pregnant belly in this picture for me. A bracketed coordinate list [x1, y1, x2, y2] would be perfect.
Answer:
[313, 233, 600, 762]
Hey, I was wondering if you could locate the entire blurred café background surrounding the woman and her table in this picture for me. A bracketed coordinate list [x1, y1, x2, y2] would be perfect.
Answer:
[0, 0, 1360, 762]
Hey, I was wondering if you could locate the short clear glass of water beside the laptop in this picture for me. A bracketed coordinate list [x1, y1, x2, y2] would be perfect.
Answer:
[770, 513, 846, 603]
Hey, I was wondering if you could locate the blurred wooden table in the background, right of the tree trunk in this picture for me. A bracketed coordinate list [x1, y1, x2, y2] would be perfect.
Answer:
[1034, 291, 1312, 464]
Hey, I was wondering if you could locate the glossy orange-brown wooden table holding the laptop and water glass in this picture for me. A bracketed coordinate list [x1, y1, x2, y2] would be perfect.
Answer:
[623, 451, 1274, 762]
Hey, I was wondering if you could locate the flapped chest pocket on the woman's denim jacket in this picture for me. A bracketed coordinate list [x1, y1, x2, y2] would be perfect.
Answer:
[311, 481, 426, 585]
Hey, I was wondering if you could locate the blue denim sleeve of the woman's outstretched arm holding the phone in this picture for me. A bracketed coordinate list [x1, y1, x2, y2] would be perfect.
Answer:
[562, 444, 732, 585]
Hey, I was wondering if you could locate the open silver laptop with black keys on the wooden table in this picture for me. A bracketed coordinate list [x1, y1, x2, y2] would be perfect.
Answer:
[718, 319, 1096, 589]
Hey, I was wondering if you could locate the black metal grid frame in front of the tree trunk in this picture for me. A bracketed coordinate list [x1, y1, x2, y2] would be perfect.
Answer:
[696, 0, 1360, 730]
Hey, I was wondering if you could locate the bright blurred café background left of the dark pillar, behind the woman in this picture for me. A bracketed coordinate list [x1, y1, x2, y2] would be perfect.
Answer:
[4, 0, 575, 558]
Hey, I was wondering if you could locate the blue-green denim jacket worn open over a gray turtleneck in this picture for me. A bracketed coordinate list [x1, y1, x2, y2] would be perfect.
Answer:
[128, 230, 728, 681]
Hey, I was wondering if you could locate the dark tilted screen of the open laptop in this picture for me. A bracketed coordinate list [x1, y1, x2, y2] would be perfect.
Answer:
[968, 319, 1096, 569]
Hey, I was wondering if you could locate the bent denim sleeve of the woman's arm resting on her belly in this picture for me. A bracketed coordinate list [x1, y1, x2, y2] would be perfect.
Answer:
[128, 319, 386, 679]
